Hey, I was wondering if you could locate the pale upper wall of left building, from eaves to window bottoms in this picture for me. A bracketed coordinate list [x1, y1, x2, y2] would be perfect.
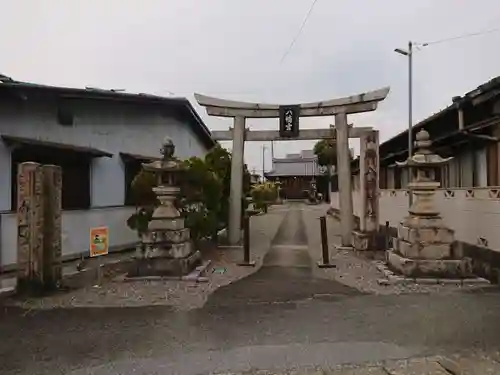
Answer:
[0, 97, 207, 211]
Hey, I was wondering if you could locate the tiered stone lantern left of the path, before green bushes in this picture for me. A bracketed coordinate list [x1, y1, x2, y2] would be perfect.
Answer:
[129, 137, 201, 277]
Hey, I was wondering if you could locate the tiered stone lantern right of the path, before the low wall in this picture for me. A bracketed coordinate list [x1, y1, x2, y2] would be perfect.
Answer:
[387, 130, 471, 278]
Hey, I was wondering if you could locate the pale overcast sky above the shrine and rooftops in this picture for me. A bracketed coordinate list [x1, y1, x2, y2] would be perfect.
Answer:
[0, 0, 500, 171]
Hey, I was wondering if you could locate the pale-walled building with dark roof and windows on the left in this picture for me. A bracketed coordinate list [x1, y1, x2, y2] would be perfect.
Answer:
[0, 75, 215, 269]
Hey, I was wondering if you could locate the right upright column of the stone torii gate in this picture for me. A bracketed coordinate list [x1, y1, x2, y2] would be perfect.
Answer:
[335, 113, 354, 247]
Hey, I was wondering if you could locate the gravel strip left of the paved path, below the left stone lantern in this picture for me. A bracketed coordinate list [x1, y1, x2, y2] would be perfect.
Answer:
[6, 206, 286, 310]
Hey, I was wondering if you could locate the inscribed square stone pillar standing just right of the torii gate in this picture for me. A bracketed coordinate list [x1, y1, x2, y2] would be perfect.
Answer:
[353, 130, 379, 250]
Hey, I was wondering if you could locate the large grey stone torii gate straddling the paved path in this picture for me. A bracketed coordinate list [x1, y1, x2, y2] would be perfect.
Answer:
[194, 87, 389, 246]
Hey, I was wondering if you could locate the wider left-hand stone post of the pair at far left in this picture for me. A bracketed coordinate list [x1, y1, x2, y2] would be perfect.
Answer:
[17, 162, 44, 293]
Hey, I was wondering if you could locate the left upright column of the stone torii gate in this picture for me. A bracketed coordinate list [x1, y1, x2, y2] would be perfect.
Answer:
[228, 117, 245, 245]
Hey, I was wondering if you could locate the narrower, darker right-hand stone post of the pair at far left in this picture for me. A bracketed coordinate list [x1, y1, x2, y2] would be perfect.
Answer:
[42, 165, 62, 288]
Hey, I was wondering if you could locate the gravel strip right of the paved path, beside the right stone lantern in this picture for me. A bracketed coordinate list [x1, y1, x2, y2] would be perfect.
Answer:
[303, 205, 494, 295]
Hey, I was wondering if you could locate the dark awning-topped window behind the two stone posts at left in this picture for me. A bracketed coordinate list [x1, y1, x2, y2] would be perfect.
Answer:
[11, 147, 91, 210]
